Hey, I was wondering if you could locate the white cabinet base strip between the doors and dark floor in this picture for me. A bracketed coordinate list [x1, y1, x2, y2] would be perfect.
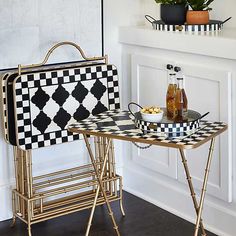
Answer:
[123, 168, 236, 236]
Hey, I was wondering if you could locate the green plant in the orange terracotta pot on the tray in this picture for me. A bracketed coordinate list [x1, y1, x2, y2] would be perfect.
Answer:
[187, 0, 214, 25]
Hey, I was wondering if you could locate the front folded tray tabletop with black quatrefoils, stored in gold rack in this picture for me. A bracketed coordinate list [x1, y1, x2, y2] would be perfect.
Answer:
[15, 65, 120, 150]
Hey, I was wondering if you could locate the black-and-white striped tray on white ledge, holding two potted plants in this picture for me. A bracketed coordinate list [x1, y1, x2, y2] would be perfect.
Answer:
[145, 15, 231, 32]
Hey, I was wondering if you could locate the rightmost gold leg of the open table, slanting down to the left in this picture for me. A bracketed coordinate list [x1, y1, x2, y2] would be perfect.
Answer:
[194, 138, 215, 236]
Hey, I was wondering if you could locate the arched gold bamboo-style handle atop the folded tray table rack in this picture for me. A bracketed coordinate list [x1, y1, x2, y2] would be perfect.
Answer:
[18, 41, 108, 75]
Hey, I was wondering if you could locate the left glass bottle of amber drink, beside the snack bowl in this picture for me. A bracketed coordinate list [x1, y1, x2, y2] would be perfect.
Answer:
[166, 74, 177, 120]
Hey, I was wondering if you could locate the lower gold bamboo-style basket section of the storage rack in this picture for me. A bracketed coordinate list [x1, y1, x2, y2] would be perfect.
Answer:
[13, 175, 122, 224]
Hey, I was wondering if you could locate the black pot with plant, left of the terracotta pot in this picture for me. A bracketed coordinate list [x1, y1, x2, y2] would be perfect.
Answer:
[155, 0, 187, 25]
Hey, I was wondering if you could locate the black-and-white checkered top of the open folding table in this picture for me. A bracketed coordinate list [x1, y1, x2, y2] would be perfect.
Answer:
[68, 110, 227, 149]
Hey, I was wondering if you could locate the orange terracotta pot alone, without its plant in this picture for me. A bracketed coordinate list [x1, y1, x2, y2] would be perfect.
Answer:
[186, 11, 209, 25]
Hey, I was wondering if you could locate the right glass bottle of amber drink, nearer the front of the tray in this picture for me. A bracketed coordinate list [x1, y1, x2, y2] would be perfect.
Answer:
[175, 78, 188, 122]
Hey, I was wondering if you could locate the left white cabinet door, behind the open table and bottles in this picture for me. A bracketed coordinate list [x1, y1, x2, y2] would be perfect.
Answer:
[131, 55, 177, 179]
